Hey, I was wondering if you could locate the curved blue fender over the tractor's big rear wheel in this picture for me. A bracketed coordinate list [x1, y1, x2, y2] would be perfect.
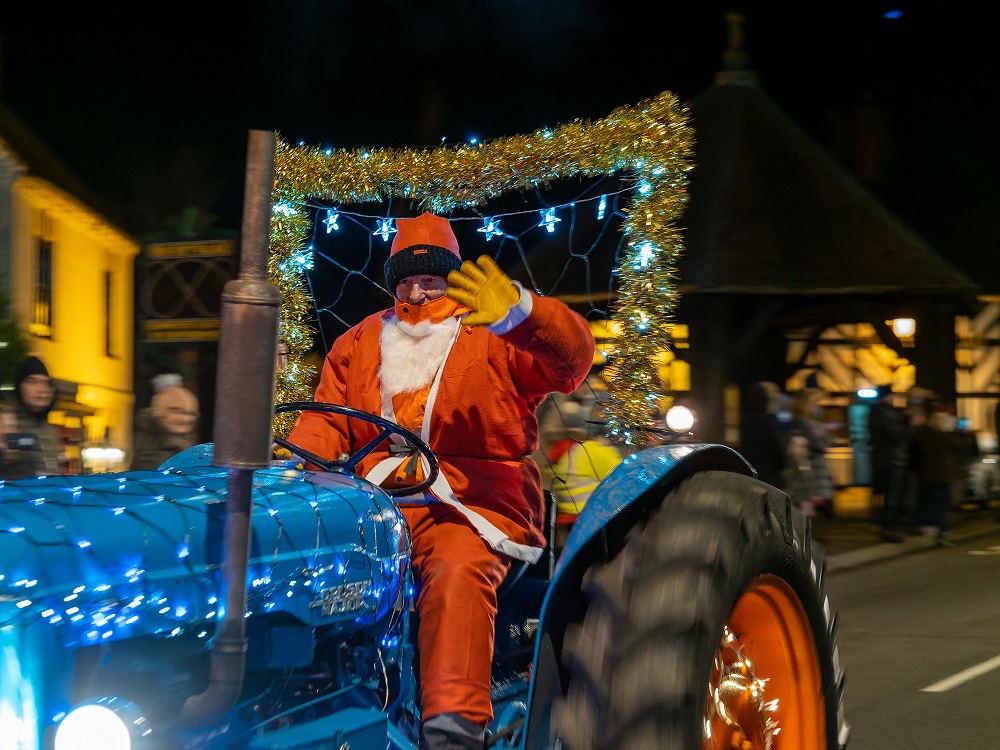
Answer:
[522, 444, 755, 750]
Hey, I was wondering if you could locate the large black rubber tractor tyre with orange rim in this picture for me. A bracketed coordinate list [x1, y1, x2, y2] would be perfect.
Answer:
[553, 471, 849, 750]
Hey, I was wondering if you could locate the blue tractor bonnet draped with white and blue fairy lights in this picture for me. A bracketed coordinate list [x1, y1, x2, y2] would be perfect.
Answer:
[0, 468, 403, 646]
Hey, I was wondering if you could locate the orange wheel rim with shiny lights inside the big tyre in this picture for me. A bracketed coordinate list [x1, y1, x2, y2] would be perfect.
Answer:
[703, 575, 826, 750]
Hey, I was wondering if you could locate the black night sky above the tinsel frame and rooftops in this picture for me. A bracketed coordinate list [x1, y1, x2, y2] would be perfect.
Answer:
[0, 0, 1000, 292]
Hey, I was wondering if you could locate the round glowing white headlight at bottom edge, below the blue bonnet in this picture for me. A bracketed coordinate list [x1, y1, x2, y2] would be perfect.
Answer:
[55, 698, 152, 750]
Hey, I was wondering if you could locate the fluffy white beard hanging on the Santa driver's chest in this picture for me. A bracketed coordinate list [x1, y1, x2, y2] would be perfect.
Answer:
[378, 318, 460, 399]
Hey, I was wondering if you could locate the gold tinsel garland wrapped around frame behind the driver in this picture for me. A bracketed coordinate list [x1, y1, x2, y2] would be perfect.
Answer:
[268, 92, 693, 444]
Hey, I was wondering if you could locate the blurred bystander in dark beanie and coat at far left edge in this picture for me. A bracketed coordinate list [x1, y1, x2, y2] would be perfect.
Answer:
[0, 356, 62, 480]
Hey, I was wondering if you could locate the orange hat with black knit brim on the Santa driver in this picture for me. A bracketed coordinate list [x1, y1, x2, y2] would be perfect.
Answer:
[385, 213, 462, 295]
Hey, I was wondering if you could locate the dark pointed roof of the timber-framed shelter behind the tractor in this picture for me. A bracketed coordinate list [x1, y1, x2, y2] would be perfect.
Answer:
[679, 77, 974, 295]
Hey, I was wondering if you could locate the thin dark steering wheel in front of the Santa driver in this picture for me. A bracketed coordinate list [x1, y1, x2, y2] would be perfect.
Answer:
[274, 401, 440, 497]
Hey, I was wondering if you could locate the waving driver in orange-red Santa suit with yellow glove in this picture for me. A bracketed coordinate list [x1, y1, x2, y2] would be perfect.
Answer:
[289, 213, 594, 750]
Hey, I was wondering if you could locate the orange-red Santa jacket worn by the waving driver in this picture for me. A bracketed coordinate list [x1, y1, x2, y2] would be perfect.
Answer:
[289, 295, 594, 547]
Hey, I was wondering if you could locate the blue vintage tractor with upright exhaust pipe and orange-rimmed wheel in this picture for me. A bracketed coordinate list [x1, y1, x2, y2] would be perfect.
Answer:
[0, 136, 848, 750]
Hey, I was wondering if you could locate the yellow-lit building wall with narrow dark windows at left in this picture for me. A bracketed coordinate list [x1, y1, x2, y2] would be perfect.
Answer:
[10, 176, 139, 449]
